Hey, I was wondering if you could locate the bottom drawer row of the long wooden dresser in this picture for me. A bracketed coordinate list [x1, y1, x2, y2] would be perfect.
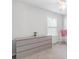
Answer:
[16, 44, 52, 59]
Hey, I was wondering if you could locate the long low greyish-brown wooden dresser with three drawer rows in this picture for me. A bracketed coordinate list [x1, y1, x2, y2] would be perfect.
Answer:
[16, 36, 52, 59]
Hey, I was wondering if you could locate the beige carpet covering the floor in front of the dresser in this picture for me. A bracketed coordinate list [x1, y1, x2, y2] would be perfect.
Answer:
[14, 44, 67, 59]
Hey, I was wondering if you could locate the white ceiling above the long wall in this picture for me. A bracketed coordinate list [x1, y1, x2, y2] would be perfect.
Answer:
[18, 0, 67, 15]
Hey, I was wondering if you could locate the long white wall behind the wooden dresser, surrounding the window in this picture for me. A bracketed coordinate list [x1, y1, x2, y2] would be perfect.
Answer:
[12, 2, 62, 54]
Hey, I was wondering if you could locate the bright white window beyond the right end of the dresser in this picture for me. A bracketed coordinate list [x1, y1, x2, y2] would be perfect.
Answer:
[47, 17, 57, 36]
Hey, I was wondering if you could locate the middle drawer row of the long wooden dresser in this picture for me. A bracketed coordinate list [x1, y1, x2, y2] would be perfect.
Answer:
[16, 40, 52, 52]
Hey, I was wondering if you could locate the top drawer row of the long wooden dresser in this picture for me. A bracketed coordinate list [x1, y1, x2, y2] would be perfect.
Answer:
[16, 36, 51, 46]
